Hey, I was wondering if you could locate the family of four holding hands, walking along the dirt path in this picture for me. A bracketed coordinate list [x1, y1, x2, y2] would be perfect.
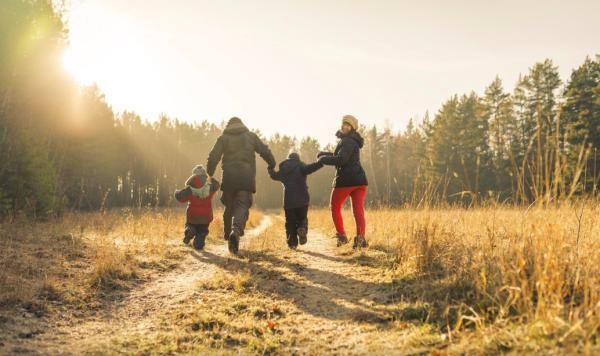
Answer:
[175, 115, 368, 254]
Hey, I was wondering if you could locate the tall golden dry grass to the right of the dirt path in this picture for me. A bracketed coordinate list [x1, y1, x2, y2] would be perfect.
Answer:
[311, 202, 600, 350]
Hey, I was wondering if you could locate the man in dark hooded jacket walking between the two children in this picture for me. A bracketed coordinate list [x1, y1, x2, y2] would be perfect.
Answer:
[206, 117, 275, 254]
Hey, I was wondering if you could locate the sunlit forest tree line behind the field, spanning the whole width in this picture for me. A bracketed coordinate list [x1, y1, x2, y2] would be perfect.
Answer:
[0, 0, 600, 216]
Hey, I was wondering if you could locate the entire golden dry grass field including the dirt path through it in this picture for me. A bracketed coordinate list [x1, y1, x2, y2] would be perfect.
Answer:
[0, 203, 600, 355]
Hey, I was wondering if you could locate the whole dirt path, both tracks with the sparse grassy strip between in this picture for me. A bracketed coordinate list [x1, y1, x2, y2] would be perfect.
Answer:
[11, 216, 440, 354]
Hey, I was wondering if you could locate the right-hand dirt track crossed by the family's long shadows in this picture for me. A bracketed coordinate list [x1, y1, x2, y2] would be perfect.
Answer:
[216, 225, 409, 355]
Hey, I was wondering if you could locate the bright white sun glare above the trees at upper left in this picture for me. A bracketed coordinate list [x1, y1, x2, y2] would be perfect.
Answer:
[62, 1, 182, 119]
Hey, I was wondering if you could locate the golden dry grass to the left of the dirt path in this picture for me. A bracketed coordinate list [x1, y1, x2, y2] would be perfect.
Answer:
[0, 208, 262, 312]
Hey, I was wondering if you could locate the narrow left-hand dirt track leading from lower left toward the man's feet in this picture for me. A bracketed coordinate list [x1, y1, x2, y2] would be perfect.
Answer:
[16, 216, 273, 354]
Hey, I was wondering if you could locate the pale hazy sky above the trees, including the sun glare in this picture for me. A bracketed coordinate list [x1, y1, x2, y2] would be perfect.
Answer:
[64, 0, 600, 144]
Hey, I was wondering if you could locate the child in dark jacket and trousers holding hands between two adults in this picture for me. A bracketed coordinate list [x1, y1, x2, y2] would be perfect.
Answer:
[269, 153, 323, 249]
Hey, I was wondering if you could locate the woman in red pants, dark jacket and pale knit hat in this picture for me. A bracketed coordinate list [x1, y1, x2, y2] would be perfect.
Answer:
[318, 115, 368, 249]
